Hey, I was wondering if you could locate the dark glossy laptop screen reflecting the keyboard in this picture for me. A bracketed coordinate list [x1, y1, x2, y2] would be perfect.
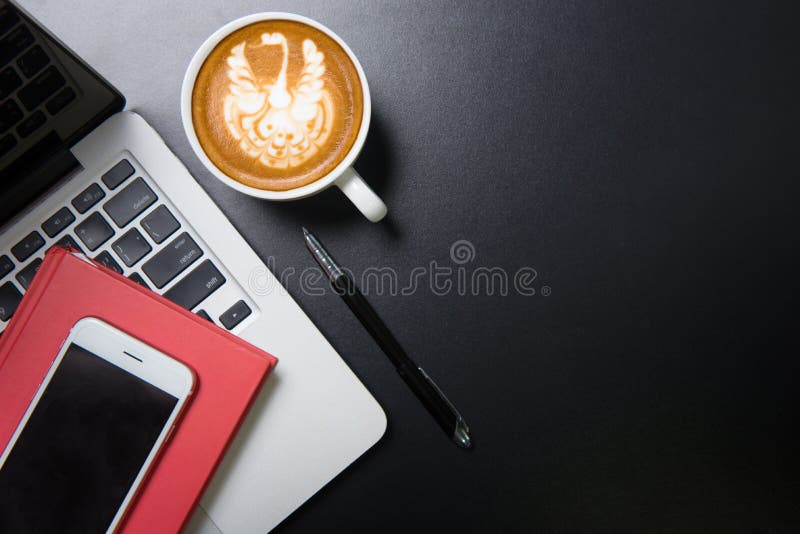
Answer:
[0, 0, 125, 226]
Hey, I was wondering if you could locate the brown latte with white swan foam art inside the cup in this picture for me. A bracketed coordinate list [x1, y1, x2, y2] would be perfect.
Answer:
[192, 20, 364, 191]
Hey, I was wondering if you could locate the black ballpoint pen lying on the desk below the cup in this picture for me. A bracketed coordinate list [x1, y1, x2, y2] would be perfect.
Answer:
[303, 228, 472, 449]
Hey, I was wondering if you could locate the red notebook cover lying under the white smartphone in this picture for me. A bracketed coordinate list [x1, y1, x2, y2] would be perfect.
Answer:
[0, 247, 277, 532]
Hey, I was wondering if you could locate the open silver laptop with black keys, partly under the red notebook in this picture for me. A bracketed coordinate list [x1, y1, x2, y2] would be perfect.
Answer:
[0, 0, 386, 533]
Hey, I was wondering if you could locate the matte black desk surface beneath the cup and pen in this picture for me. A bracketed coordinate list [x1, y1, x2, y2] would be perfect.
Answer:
[23, 0, 800, 533]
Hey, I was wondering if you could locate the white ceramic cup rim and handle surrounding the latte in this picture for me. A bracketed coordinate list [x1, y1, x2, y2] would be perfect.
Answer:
[181, 12, 386, 222]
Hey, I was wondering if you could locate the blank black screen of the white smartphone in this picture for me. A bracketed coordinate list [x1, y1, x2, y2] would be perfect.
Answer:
[0, 343, 178, 533]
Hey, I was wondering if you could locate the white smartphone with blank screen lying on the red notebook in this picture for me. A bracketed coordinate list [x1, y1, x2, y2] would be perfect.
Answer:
[0, 318, 194, 532]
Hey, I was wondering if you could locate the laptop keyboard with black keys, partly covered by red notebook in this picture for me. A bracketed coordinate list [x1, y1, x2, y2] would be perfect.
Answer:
[0, 157, 252, 332]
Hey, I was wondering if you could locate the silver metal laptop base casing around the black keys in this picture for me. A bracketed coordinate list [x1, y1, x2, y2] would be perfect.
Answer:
[0, 112, 386, 533]
